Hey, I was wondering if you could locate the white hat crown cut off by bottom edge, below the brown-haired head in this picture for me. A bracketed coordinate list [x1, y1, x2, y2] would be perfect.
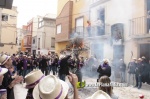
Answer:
[86, 90, 111, 99]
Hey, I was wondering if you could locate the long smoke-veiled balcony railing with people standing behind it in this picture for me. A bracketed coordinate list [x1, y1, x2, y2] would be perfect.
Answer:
[70, 24, 111, 38]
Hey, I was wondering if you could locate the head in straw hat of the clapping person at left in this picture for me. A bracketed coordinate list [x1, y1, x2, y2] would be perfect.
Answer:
[0, 55, 12, 68]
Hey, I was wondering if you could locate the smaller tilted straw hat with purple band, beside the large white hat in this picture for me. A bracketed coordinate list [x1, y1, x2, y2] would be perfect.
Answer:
[24, 70, 44, 89]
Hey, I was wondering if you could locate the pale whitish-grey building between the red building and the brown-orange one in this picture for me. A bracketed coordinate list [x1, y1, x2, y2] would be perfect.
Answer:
[33, 14, 56, 54]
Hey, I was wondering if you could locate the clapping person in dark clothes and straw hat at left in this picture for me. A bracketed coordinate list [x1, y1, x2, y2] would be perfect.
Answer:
[0, 55, 23, 99]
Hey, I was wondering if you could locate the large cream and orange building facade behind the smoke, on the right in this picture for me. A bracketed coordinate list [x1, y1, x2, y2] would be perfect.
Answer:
[56, 0, 150, 63]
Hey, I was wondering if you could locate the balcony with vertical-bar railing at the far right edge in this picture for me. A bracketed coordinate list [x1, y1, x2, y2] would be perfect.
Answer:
[129, 16, 150, 38]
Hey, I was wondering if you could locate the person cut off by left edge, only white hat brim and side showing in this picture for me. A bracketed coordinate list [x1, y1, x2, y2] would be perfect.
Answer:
[0, 67, 8, 99]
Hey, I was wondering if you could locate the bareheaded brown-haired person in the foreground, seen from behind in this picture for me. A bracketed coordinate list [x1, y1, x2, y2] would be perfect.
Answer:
[99, 76, 112, 96]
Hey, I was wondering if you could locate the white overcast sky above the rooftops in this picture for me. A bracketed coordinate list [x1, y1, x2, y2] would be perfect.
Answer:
[13, 0, 58, 28]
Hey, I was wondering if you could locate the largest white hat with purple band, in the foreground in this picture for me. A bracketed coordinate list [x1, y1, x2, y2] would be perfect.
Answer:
[33, 75, 69, 99]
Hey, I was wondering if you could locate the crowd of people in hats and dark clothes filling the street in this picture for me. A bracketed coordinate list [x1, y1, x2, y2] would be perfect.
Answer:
[0, 53, 150, 99]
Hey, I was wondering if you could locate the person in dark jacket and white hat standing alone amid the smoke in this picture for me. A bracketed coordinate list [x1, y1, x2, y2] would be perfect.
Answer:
[97, 59, 111, 82]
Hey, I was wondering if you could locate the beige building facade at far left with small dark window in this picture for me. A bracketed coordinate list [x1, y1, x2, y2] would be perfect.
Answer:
[0, 7, 18, 54]
